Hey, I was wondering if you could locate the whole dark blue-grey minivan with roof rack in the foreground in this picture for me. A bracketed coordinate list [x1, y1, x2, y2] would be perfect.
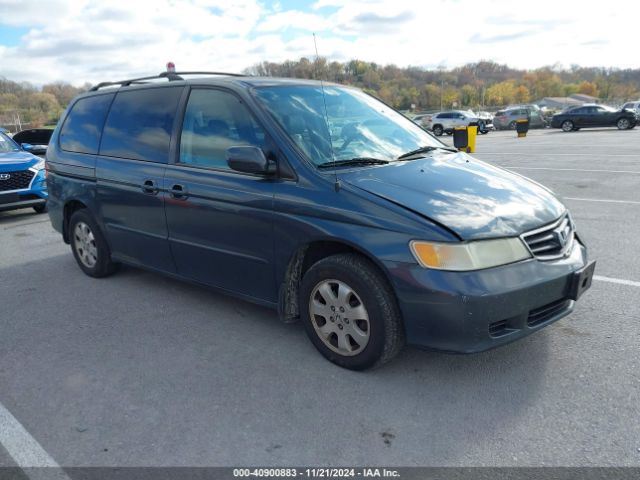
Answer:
[47, 74, 594, 369]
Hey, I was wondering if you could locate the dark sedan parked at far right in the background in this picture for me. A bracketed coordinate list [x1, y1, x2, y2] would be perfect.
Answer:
[551, 105, 638, 132]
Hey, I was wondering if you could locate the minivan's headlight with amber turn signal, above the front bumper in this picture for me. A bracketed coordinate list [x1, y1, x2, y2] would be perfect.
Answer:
[409, 238, 531, 272]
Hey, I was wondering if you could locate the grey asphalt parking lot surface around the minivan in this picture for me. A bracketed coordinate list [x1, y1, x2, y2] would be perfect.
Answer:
[0, 128, 640, 472]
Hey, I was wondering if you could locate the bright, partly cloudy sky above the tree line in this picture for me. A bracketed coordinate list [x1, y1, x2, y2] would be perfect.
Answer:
[0, 0, 640, 85]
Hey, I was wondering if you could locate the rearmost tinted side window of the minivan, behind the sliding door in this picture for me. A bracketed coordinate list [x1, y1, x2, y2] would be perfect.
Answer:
[60, 93, 115, 154]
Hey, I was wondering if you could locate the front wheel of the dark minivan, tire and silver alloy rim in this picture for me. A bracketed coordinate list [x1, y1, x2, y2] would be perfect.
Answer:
[300, 254, 404, 370]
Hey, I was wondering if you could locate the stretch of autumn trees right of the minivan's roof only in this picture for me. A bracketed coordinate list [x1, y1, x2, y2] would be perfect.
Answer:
[245, 57, 640, 110]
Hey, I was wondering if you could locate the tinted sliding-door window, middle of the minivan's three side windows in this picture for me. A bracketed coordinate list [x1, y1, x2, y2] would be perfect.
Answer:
[100, 86, 184, 163]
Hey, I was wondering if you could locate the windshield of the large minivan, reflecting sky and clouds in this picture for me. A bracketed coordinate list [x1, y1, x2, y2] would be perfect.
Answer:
[254, 85, 446, 166]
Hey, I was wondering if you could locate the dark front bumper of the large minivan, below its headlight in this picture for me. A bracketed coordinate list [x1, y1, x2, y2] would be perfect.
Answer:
[386, 240, 592, 353]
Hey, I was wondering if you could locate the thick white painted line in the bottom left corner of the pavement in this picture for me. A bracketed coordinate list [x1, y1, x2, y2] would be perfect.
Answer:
[0, 403, 70, 480]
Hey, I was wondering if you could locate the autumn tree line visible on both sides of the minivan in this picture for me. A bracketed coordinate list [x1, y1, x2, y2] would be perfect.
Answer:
[0, 57, 640, 130]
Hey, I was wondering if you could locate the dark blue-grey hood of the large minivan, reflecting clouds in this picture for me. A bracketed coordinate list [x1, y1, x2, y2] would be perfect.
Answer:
[339, 152, 566, 240]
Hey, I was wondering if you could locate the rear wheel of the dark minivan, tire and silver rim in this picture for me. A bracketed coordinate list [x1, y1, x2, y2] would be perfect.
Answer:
[69, 209, 116, 278]
